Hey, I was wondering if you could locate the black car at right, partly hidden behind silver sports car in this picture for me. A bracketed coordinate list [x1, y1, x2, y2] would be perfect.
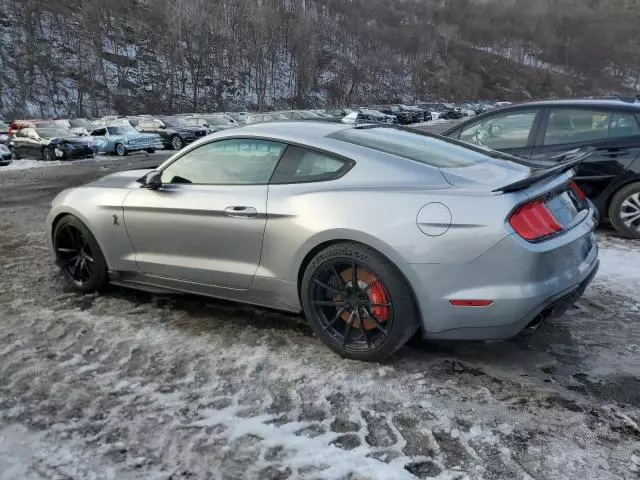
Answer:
[443, 100, 640, 238]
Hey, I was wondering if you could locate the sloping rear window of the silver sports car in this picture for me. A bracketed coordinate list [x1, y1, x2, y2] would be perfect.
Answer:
[329, 128, 526, 168]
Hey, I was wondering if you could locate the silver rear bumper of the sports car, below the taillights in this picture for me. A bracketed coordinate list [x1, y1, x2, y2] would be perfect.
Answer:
[410, 211, 599, 340]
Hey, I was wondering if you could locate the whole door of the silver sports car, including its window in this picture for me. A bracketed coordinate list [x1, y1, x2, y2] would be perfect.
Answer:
[124, 139, 285, 289]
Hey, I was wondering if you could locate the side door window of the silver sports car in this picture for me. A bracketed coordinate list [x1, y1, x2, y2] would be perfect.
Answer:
[162, 138, 285, 185]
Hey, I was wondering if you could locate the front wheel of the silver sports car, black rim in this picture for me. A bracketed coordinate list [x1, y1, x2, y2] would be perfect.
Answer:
[53, 215, 107, 293]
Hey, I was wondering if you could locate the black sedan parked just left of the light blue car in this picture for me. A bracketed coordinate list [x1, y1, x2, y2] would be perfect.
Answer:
[9, 127, 95, 161]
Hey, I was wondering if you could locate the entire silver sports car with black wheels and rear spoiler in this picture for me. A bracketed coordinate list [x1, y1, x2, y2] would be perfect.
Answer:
[47, 122, 598, 360]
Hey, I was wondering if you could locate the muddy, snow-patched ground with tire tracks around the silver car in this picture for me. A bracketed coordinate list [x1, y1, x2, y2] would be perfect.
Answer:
[0, 157, 640, 480]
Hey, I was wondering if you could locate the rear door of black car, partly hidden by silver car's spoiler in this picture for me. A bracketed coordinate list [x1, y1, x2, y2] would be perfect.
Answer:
[533, 107, 640, 199]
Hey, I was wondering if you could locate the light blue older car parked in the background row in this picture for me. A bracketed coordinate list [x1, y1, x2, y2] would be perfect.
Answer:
[91, 126, 163, 157]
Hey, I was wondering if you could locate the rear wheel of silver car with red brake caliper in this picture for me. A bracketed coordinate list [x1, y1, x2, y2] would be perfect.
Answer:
[300, 242, 418, 361]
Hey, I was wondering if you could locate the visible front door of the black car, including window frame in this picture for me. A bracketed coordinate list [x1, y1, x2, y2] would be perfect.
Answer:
[456, 107, 541, 158]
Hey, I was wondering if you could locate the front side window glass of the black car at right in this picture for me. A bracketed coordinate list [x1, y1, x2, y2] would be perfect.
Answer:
[460, 110, 538, 150]
